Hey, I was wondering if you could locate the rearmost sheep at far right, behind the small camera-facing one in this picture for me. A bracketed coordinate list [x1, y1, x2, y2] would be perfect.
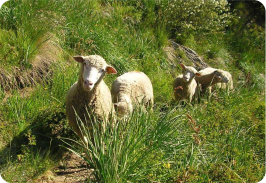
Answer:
[195, 67, 229, 93]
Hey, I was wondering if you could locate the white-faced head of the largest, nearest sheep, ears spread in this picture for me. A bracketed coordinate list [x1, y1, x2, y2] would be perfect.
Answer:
[73, 55, 117, 91]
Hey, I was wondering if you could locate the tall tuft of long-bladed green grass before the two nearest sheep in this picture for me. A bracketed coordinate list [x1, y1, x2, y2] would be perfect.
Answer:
[64, 106, 179, 182]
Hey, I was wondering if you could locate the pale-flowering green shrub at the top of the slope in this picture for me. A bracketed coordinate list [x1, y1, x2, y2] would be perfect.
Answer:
[161, 0, 231, 38]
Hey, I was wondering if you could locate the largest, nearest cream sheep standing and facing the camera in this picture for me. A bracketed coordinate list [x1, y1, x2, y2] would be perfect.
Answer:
[66, 55, 117, 144]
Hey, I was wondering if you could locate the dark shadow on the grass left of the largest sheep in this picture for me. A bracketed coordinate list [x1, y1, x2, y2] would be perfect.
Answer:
[0, 109, 75, 167]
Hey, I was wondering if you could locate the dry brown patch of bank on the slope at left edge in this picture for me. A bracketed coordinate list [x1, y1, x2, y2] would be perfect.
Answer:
[0, 35, 62, 91]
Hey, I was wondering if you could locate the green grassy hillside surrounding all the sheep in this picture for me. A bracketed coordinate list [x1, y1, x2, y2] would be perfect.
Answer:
[0, 0, 266, 182]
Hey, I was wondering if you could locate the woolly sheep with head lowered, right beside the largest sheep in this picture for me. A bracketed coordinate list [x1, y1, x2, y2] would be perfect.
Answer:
[111, 71, 153, 118]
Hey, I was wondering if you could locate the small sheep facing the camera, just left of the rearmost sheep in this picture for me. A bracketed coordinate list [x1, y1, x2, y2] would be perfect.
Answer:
[173, 64, 200, 102]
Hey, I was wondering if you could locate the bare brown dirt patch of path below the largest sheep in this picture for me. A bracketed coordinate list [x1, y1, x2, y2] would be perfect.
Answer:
[34, 153, 93, 183]
